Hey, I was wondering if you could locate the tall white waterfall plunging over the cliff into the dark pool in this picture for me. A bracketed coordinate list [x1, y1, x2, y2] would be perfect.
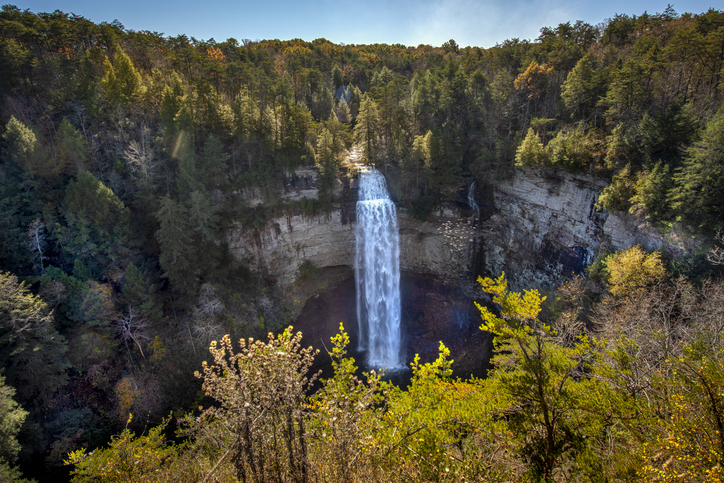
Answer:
[355, 168, 401, 368]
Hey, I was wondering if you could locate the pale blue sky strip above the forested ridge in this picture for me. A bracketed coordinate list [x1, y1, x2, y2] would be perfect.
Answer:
[3, 0, 722, 47]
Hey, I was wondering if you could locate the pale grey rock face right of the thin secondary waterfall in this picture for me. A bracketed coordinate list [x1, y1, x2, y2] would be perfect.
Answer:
[481, 172, 691, 290]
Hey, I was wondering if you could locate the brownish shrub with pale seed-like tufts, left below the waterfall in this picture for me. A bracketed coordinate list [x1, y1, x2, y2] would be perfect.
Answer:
[196, 327, 316, 483]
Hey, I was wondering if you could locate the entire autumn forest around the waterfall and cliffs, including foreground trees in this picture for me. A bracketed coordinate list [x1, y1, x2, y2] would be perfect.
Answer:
[0, 5, 724, 483]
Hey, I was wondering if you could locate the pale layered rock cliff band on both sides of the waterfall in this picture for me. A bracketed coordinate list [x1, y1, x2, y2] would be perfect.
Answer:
[228, 169, 687, 290]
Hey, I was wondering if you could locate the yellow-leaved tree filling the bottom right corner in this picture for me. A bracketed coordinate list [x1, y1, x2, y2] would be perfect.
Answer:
[635, 281, 724, 483]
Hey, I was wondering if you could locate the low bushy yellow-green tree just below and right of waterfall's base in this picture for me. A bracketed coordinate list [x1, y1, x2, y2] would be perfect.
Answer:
[376, 343, 520, 482]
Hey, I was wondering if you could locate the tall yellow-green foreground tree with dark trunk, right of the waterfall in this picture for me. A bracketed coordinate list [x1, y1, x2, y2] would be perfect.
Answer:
[476, 274, 615, 482]
